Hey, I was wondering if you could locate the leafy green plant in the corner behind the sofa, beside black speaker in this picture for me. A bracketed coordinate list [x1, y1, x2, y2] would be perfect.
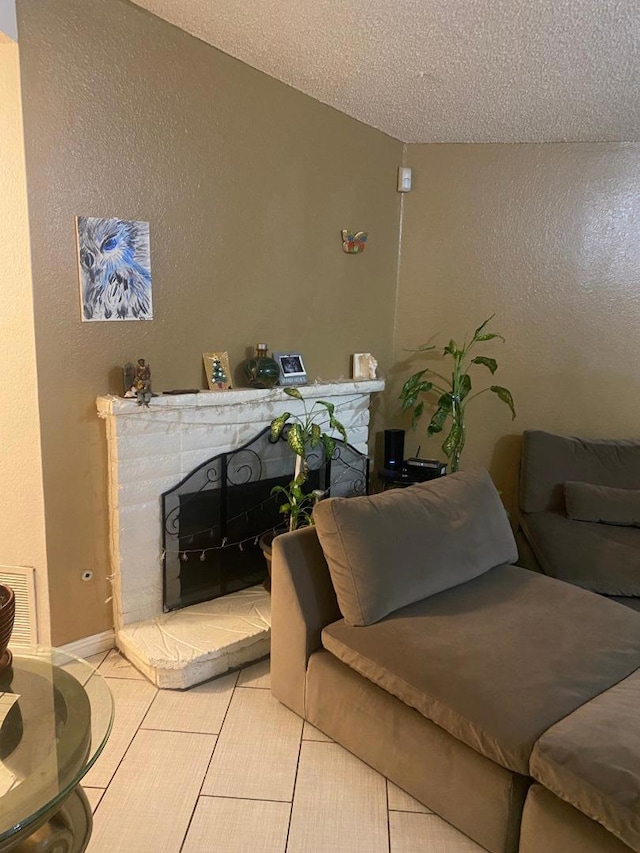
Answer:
[399, 314, 516, 471]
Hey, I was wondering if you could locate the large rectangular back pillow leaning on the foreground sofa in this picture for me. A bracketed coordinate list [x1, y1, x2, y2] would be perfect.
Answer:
[313, 469, 518, 625]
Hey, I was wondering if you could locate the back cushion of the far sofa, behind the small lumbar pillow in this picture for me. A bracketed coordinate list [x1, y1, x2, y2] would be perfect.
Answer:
[520, 430, 640, 512]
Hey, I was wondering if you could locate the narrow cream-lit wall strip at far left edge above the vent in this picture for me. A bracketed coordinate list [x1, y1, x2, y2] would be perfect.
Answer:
[0, 42, 49, 643]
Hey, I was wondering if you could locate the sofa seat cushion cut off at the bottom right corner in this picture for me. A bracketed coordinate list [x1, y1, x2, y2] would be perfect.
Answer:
[531, 672, 640, 851]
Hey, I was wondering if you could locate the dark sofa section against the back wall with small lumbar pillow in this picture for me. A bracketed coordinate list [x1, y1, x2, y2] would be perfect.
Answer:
[516, 430, 640, 610]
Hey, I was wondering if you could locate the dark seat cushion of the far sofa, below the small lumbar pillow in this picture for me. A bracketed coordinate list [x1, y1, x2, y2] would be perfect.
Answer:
[521, 511, 640, 596]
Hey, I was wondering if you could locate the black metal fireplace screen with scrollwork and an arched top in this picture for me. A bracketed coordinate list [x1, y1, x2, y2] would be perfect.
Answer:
[162, 427, 369, 612]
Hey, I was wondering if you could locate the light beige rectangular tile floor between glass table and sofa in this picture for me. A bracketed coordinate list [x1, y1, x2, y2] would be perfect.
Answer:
[82, 651, 483, 853]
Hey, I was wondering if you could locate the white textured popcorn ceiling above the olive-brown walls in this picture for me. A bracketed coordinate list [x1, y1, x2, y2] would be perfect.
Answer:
[131, 0, 640, 142]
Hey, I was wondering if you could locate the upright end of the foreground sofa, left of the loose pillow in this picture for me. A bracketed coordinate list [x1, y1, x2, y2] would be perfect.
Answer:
[271, 527, 342, 717]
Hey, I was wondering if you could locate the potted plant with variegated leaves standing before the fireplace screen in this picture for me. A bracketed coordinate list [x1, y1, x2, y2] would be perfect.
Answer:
[259, 387, 347, 568]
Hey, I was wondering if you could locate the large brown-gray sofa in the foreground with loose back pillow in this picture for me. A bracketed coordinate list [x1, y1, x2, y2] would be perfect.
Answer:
[271, 470, 640, 853]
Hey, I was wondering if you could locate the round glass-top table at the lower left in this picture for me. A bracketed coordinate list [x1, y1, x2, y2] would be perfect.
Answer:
[0, 648, 113, 853]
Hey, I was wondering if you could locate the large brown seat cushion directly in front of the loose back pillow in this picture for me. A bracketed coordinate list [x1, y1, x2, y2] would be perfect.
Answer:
[322, 566, 640, 774]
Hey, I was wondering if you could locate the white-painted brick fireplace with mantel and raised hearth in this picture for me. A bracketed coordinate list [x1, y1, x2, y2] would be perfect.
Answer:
[97, 380, 384, 689]
